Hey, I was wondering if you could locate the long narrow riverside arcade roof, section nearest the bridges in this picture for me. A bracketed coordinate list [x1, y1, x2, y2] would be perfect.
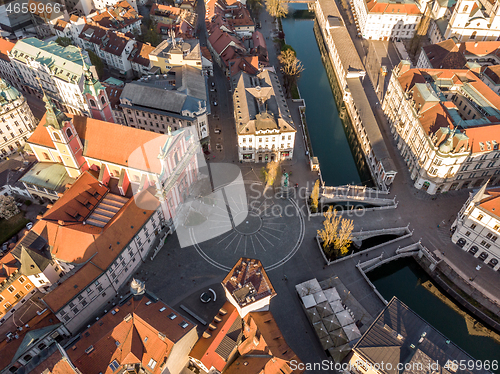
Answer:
[347, 77, 397, 172]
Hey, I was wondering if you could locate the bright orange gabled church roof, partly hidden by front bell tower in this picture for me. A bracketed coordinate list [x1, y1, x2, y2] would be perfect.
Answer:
[28, 113, 167, 174]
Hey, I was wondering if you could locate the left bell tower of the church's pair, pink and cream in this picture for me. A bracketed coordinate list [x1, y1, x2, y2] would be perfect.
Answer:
[43, 95, 88, 178]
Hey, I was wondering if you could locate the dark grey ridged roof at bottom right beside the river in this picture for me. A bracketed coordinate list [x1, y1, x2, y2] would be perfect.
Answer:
[354, 297, 489, 374]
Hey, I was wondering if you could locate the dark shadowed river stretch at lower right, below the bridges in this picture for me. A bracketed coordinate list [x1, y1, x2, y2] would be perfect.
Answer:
[368, 259, 500, 373]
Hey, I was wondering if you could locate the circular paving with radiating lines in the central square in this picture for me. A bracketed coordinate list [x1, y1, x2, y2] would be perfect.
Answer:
[188, 181, 305, 271]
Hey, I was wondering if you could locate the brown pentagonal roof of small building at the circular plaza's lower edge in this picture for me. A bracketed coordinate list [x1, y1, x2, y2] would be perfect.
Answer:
[222, 257, 276, 307]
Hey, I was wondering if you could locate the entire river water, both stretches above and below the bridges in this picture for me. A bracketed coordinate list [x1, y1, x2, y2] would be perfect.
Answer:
[282, 4, 500, 373]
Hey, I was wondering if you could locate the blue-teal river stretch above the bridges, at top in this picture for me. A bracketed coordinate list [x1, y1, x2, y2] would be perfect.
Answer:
[282, 4, 371, 186]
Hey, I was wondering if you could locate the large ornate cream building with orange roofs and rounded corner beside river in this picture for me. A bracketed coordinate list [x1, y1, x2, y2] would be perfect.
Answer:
[382, 61, 500, 195]
